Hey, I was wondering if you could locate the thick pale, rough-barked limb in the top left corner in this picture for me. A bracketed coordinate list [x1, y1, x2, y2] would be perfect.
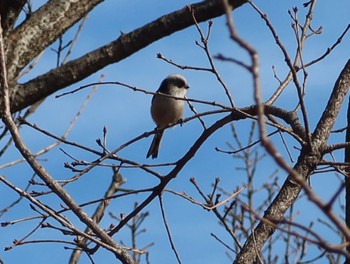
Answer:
[5, 0, 103, 80]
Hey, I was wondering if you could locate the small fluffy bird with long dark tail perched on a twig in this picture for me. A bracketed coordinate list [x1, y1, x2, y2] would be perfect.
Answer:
[146, 74, 189, 159]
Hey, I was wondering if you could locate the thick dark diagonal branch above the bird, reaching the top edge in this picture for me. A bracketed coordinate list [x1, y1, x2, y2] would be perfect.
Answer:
[11, 0, 246, 112]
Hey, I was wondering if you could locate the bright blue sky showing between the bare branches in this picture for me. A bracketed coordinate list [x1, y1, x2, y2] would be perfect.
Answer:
[0, 0, 350, 264]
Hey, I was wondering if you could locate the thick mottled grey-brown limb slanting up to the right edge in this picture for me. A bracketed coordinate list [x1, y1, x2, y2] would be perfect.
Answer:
[234, 60, 350, 263]
